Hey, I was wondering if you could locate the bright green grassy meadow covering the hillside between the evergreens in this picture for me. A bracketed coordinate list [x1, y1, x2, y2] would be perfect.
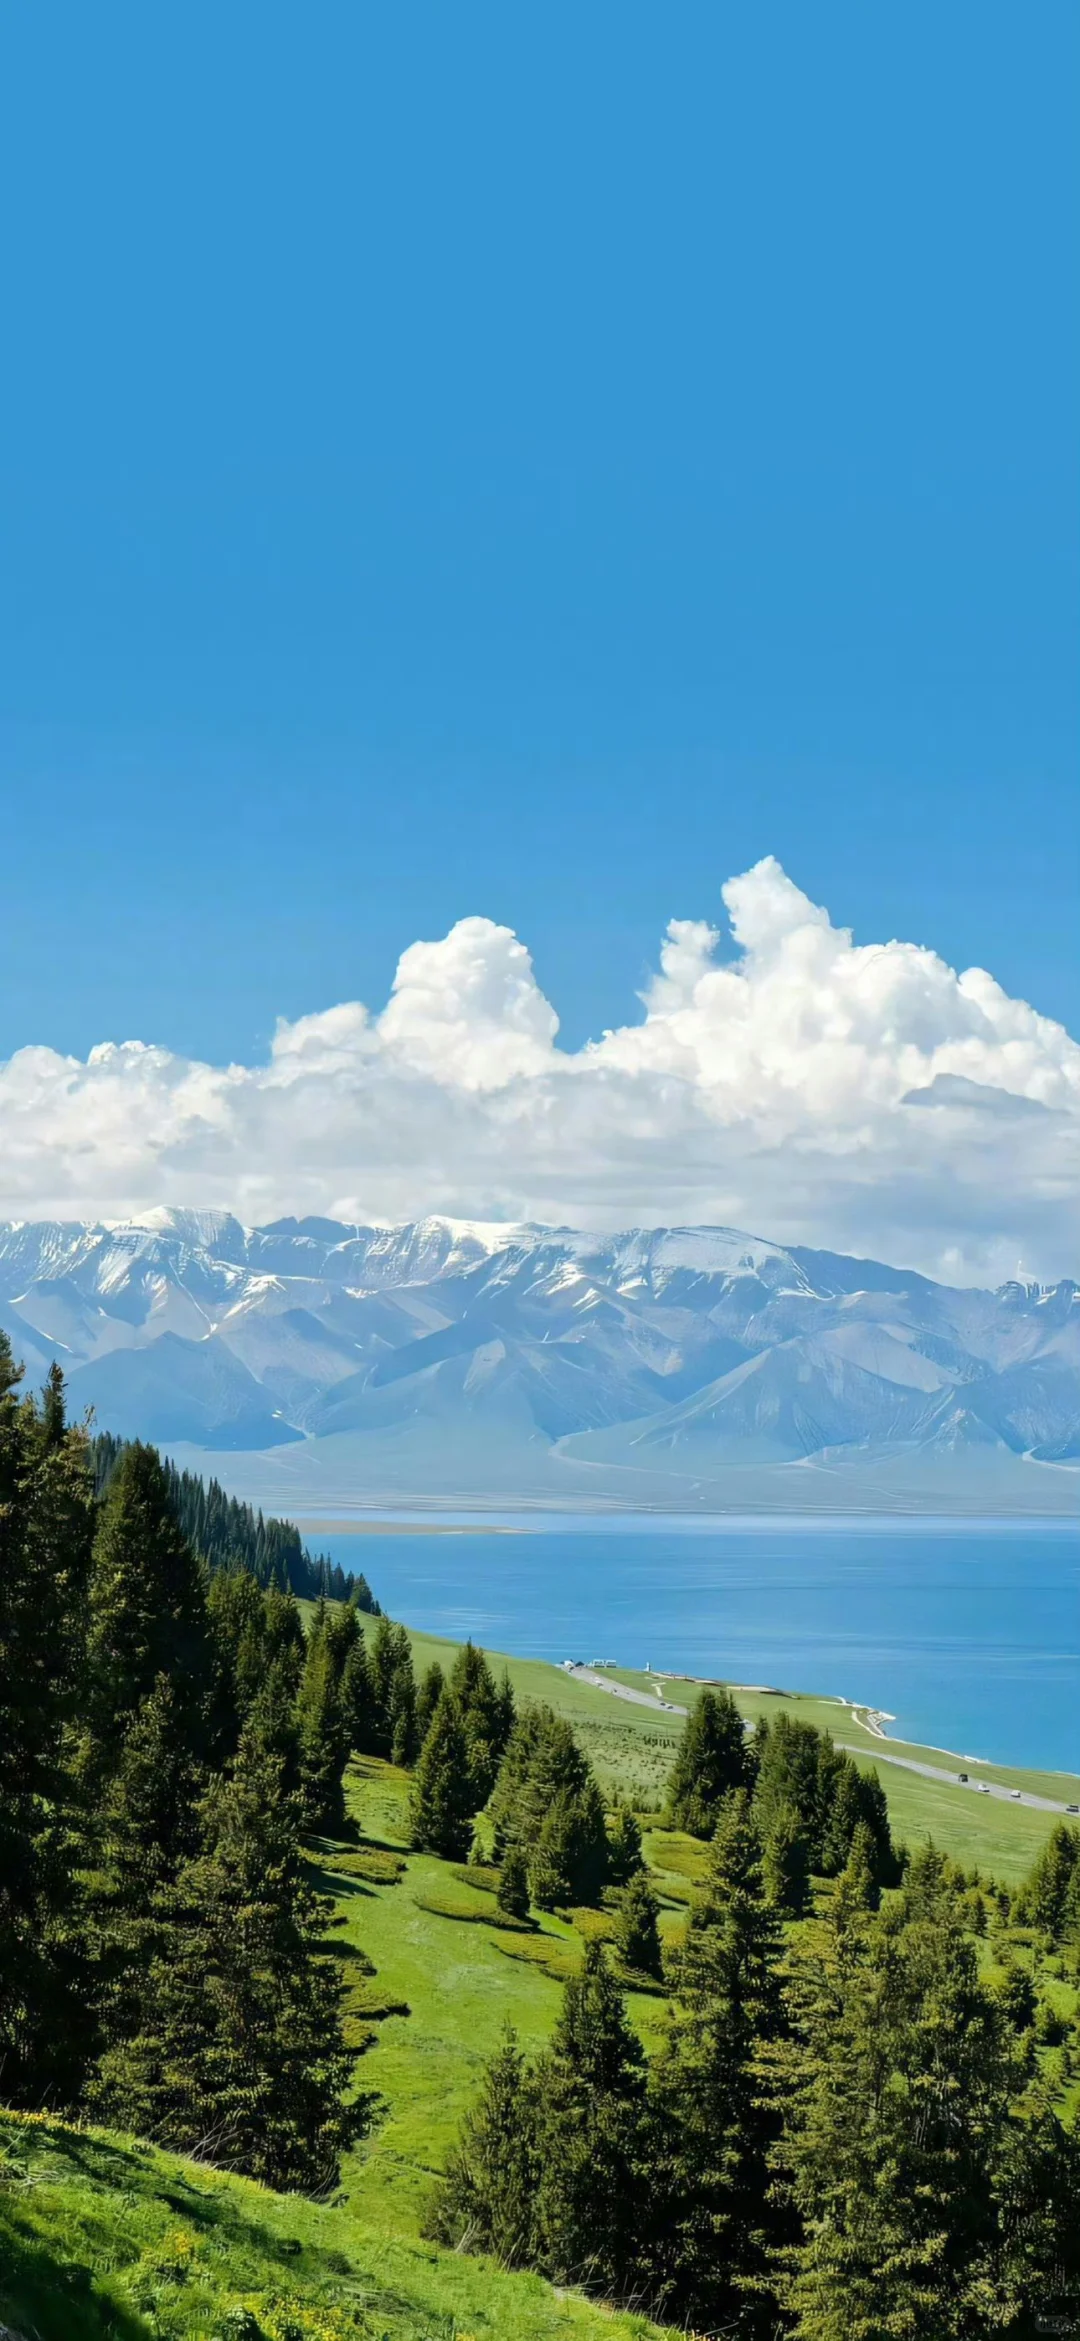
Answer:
[0, 1634, 1075, 2341]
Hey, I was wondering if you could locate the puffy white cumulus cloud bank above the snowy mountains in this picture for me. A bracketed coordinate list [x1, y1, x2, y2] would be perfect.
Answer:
[0, 857, 1080, 1278]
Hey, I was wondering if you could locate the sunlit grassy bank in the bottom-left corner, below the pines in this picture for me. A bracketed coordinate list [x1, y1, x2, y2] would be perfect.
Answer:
[0, 2114, 656, 2341]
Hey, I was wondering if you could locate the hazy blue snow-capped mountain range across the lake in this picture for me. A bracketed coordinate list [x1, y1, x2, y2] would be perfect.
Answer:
[0, 1210, 1080, 1515]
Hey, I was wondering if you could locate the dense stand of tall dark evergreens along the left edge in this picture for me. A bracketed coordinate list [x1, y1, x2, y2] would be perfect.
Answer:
[0, 1337, 384, 2189]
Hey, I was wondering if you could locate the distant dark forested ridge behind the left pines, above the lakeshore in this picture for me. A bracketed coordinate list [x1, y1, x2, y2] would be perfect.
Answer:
[94, 1430, 380, 1615]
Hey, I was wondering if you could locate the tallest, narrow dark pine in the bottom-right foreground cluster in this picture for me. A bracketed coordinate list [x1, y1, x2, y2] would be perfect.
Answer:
[656, 1791, 785, 2336]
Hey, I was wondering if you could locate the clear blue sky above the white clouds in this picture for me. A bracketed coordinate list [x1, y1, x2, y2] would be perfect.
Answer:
[0, 0, 1080, 1090]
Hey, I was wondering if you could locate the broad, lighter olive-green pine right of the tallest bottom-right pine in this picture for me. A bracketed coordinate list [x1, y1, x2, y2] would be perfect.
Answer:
[782, 1859, 1038, 2341]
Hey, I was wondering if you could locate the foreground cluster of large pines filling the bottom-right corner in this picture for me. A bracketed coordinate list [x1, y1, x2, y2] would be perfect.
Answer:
[429, 1789, 1080, 2341]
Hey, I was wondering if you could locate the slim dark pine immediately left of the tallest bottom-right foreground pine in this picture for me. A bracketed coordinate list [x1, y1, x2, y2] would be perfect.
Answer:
[536, 1943, 647, 2299]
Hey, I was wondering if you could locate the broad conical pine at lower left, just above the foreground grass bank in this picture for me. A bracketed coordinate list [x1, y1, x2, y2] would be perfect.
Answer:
[91, 1739, 363, 2191]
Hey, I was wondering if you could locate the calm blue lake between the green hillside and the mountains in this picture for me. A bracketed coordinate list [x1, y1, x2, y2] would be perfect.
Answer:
[318, 1515, 1080, 1772]
